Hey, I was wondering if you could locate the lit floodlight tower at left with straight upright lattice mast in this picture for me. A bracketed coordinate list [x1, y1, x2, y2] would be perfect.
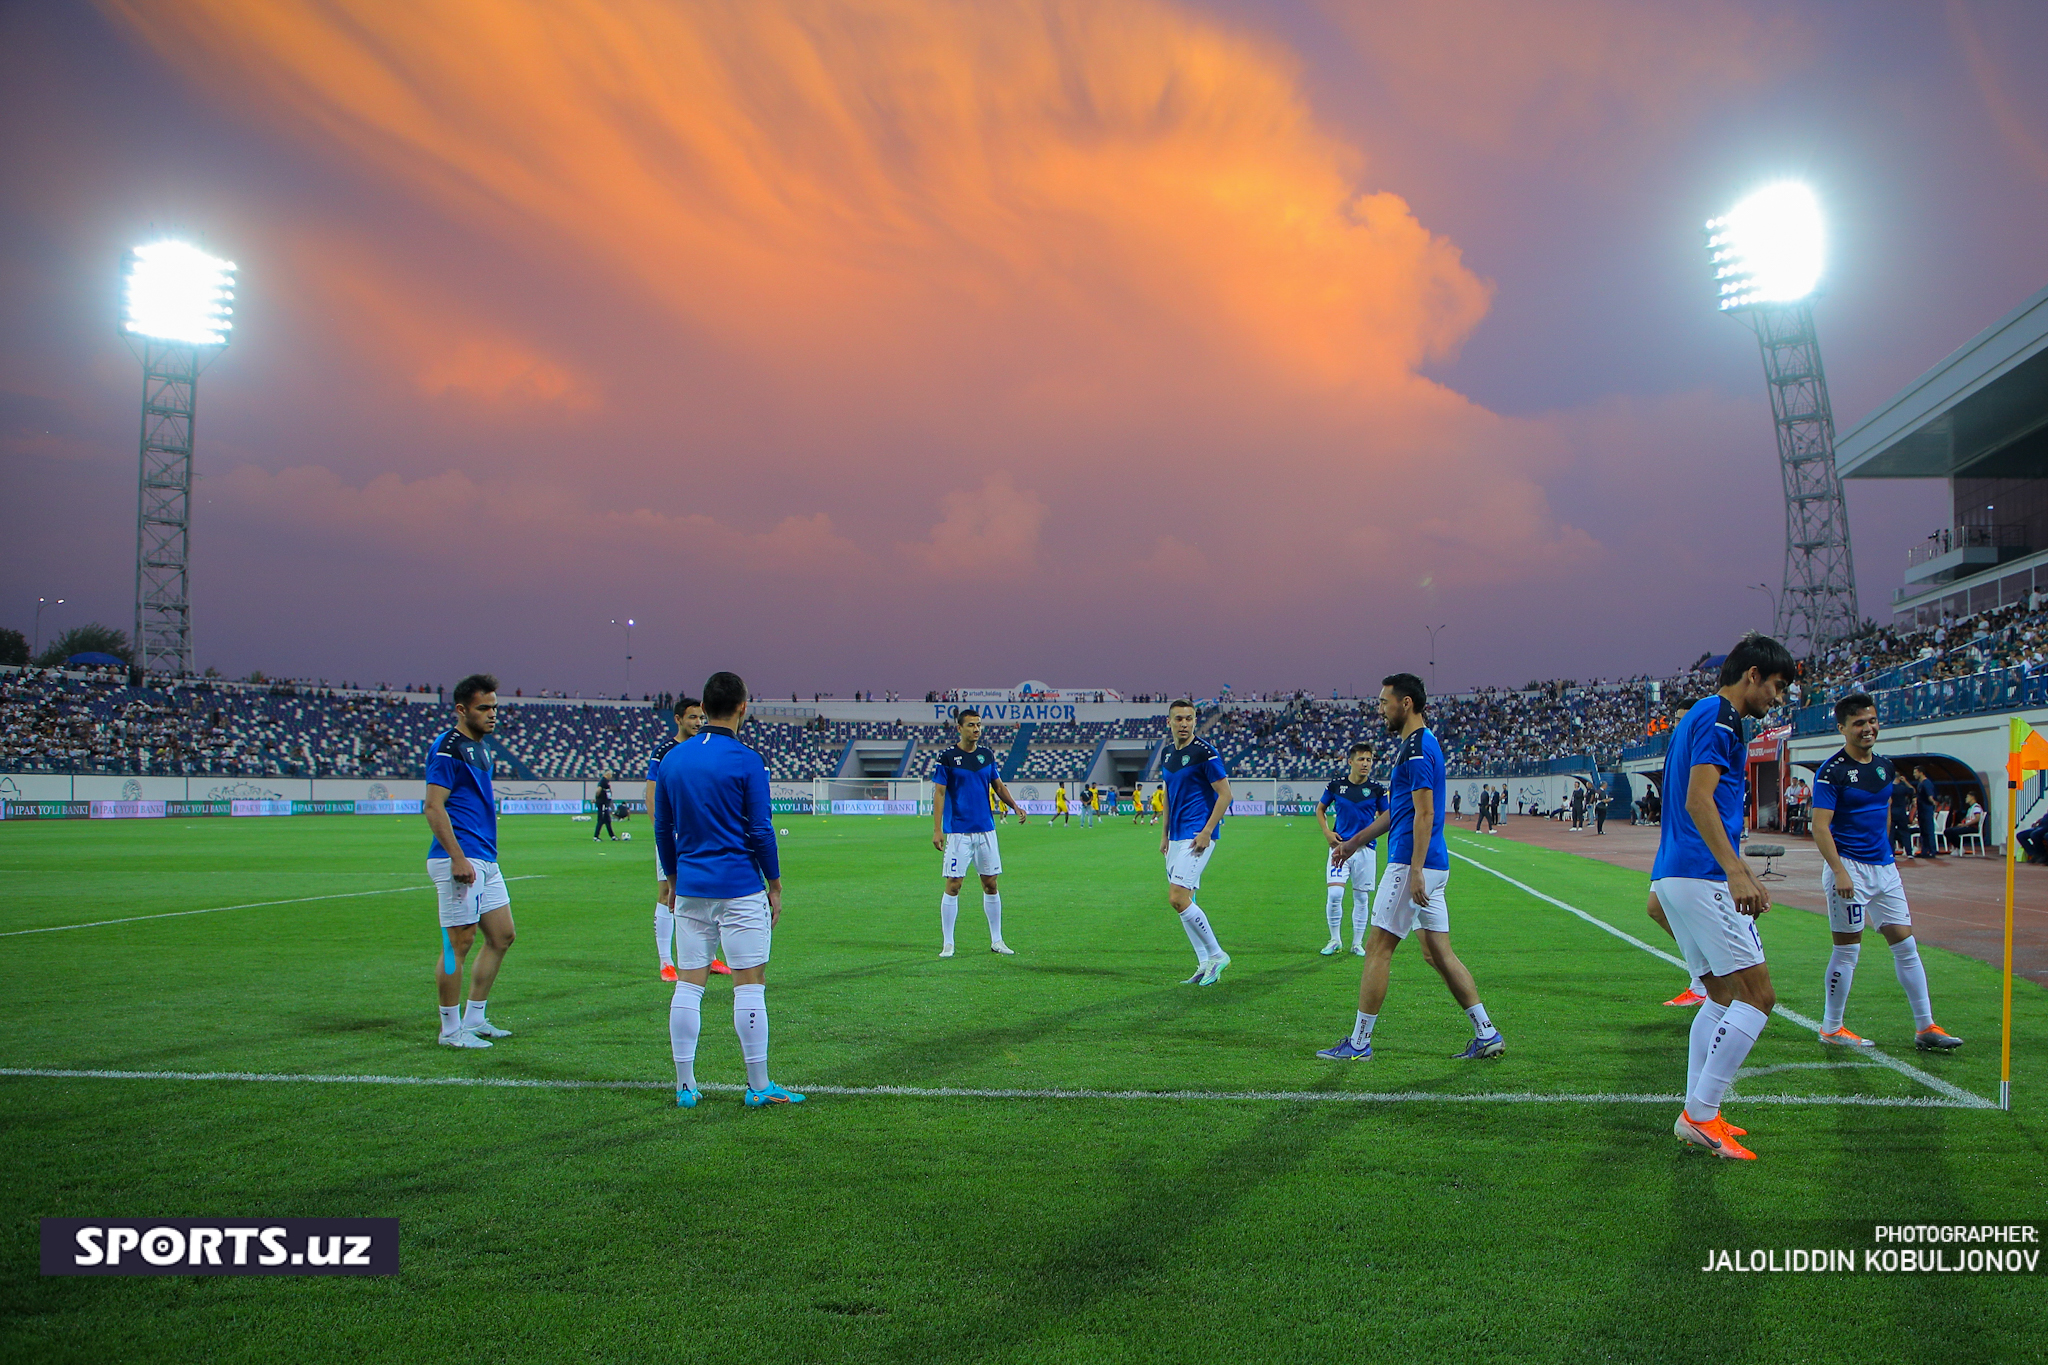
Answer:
[121, 241, 236, 675]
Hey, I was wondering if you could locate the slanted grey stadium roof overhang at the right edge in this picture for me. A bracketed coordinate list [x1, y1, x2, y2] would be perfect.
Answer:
[1835, 278, 2048, 479]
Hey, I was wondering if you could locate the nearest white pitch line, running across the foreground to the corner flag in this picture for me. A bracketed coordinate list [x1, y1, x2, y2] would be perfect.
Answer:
[0, 1066, 1972, 1109]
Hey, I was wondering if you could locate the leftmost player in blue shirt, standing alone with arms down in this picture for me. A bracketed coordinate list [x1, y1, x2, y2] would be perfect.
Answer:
[426, 673, 512, 1048]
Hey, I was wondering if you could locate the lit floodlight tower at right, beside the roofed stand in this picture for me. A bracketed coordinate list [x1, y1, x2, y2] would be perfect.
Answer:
[1706, 182, 1862, 655]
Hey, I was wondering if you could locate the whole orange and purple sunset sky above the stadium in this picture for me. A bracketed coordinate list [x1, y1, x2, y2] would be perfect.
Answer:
[0, 0, 2048, 696]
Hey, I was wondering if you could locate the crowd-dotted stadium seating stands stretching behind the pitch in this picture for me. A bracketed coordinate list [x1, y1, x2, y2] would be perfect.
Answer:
[16, 593, 2048, 782]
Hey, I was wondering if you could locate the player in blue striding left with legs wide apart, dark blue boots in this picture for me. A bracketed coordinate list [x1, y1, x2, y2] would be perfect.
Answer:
[1317, 673, 1507, 1062]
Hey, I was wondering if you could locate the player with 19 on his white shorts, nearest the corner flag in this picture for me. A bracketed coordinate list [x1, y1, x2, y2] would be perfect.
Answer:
[1812, 692, 1962, 1052]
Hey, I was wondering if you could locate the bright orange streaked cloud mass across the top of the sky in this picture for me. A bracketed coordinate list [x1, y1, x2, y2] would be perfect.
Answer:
[109, 0, 1487, 387]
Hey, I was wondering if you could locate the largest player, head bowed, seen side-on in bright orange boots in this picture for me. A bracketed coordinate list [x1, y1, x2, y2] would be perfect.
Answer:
[1651, 634, 1798, 1160]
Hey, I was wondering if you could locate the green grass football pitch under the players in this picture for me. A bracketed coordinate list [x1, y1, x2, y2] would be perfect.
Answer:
[0, 817, 2048, 1365]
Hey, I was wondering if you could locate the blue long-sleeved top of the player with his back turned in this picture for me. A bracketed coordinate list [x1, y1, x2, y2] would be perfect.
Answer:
[653, 724, 782, 900]
